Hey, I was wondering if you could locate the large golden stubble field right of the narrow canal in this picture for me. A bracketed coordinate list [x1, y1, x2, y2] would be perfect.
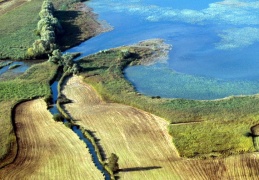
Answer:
[62, 76, 259, 180]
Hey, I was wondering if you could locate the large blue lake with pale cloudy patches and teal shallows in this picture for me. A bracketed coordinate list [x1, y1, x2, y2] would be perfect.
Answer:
[66, 0, 259, 99]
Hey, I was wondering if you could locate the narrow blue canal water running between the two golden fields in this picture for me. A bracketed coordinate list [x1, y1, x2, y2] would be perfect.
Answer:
[49, 81, 111, 180]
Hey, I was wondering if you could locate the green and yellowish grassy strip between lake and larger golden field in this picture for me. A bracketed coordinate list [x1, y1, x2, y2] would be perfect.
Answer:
[79, 46, 259, 158]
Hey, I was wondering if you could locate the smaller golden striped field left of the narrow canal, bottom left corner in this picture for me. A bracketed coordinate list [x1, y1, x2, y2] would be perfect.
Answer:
[0, 99, 103, 180]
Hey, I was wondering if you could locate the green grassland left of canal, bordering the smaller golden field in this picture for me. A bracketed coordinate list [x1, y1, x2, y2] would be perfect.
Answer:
[0, 62, 57, 167]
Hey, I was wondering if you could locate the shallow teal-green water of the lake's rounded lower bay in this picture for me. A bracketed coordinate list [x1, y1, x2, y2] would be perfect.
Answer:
[124, 64, 259, 100]
